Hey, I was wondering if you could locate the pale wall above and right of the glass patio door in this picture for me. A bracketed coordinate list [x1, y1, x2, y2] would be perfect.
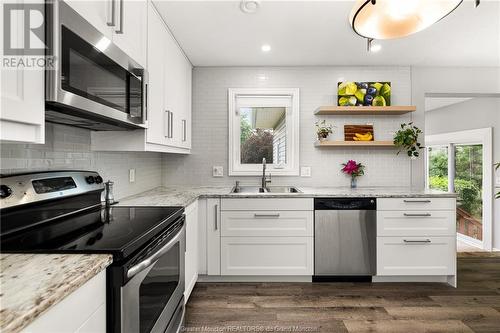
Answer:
[425, 97, 500, 249]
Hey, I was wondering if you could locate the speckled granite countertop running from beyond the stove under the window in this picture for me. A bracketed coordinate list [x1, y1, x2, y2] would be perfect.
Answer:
[118, 186, 456, 207]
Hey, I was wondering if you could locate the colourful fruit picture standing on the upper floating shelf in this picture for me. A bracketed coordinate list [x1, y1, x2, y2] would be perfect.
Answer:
[337, 82, 391, 106]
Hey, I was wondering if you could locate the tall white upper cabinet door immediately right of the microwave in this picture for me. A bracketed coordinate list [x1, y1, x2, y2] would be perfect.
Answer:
[146, 3, 168, 145]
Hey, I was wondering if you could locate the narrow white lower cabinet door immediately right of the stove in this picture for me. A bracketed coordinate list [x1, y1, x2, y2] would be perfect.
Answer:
[184, 201, 198, 302]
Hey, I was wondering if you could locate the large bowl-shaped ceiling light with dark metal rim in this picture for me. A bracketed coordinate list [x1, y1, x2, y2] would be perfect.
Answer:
[349, 0, 463, 39]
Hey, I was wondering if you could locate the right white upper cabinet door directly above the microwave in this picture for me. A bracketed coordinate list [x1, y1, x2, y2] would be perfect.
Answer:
[113, 0, 148, 66]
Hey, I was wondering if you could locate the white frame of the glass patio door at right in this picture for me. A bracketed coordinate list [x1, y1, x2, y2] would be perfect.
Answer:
[425, 127, 494, 251]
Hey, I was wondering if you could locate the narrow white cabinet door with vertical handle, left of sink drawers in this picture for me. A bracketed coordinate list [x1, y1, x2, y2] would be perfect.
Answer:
[206, 199, 221, 275]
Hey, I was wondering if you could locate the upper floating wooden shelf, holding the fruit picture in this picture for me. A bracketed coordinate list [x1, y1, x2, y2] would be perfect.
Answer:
[314, 105, 417, 116]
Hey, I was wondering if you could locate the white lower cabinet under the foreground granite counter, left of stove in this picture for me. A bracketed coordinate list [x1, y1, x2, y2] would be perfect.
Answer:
[21, 271, 106, 333]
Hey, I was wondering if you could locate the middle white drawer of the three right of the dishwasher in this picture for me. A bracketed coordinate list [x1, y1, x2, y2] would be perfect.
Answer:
[377, 210, 456, 236]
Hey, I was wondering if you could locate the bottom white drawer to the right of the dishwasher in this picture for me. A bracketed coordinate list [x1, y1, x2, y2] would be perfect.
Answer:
[377, 237, 456, 276]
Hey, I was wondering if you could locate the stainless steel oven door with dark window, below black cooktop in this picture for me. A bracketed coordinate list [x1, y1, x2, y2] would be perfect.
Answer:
[120, 220, 185, 333]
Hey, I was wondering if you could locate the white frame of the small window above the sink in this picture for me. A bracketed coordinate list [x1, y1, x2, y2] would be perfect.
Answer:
[228, 88, 300, 176]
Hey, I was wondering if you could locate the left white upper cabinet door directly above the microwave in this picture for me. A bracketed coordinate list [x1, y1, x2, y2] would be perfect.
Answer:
[64, 0, 113, 40]
